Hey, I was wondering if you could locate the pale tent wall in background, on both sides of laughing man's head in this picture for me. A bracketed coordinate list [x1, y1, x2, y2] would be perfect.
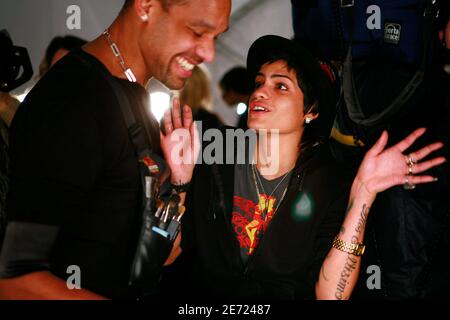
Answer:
[0, 0, 293, 125]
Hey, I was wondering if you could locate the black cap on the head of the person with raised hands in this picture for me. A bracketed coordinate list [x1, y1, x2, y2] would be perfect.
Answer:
[247, 35, 337, 138]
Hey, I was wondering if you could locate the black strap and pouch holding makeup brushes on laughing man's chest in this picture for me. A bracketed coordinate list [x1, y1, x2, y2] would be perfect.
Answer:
[74, 52, 185, 299]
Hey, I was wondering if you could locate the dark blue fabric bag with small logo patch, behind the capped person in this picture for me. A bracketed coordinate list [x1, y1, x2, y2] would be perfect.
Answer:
[292, 0, 426, 64]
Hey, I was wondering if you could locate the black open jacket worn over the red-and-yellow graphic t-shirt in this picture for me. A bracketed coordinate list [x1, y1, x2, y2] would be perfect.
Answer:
[182, 131, 356, 299]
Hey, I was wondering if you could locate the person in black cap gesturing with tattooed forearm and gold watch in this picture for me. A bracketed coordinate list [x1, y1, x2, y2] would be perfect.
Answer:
[162, 36, 445, 299]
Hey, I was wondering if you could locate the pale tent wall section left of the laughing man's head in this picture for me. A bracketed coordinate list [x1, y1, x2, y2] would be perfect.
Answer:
[0, 0, 124, 92]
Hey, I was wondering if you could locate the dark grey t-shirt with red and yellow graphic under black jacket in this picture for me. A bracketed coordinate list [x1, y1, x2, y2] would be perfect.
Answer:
[231, 164, 292, 264]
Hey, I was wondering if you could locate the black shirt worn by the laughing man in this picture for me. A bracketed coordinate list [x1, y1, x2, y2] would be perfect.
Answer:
[2, 50, 159, 298]
